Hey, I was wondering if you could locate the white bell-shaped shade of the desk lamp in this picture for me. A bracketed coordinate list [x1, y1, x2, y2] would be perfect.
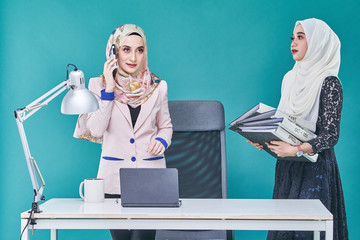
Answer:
[61, 70, 99, 114]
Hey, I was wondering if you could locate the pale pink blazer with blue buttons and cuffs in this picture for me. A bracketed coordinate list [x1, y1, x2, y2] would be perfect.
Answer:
[75, 77, 173, 194]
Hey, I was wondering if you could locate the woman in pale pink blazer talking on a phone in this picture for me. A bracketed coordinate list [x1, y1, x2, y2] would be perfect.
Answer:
[74, 24, 172, 239]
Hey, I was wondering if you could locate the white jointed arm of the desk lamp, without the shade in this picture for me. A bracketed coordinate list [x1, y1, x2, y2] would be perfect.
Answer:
[14, 80, 68, 212]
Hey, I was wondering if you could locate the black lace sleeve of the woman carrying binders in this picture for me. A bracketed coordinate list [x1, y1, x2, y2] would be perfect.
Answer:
[308, 76, 343, 153]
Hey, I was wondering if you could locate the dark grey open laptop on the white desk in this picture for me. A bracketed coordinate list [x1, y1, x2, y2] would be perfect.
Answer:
[119, 168, 181, 207]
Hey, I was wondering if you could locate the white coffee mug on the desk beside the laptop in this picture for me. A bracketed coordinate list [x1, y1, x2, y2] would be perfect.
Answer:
[79, 178, 104, 203]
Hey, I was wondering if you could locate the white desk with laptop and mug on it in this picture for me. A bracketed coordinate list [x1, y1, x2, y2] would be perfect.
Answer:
[21, 198, 333, 240]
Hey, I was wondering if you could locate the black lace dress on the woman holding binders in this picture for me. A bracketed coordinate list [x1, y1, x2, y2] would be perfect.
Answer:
[267, 77, 348, 240]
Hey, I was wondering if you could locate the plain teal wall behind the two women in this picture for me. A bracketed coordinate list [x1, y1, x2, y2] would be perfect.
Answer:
[0, 0, 360, 239]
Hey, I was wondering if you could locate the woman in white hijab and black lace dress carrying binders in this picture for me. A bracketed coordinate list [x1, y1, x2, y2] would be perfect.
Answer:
[252, 18, 348, 240]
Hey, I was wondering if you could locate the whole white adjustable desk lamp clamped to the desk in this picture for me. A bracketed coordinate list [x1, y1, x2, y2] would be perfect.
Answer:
[14, 64, 99, 213]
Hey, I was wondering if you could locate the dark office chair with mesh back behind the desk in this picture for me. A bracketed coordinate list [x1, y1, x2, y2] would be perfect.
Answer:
[156, 101, 233, 240]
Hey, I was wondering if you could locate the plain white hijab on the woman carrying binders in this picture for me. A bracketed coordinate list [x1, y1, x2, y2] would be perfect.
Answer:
[278, 18, 340, 131]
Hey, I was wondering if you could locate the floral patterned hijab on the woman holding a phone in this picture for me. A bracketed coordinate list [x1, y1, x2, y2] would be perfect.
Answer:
[106, 24, 160, 108]
